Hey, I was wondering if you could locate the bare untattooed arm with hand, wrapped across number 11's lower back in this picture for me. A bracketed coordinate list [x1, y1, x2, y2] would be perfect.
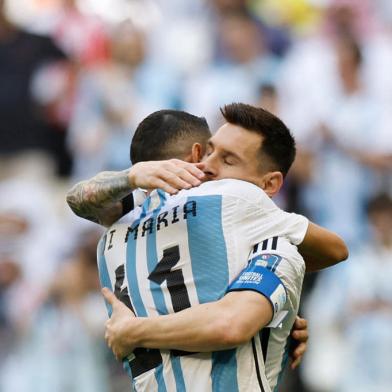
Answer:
[102, 288, 272, 359]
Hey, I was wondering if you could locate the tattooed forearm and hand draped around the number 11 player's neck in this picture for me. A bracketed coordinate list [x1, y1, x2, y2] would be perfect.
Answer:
[67, 159, 204, 227]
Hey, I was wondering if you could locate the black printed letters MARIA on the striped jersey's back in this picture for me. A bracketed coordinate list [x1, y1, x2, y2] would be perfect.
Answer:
[125, 200, 197, 242]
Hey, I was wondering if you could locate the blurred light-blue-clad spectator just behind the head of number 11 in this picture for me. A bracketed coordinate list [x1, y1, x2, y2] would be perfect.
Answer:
[69, 22, 176, 178]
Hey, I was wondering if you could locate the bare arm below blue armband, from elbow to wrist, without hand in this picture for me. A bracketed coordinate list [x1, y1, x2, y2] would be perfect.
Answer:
[130, 292, 272, 352]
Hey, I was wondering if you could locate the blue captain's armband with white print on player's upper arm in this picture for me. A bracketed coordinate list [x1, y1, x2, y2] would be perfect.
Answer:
[227, 254, 287, 318]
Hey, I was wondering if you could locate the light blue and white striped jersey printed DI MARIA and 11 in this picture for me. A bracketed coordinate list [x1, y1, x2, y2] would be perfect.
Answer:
[98, 180, 308, 392]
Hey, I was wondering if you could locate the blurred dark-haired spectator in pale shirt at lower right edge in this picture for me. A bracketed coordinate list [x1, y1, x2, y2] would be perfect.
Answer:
[305, 194, 392, 392]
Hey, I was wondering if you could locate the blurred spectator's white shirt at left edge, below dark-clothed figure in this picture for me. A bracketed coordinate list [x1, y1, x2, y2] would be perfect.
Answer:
[0, 178, 66, 288]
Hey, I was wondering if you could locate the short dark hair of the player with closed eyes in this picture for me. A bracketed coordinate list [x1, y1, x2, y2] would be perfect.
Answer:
[221, 103, 296, 176]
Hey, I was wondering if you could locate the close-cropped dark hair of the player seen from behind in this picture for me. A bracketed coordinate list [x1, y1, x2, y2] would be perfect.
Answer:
[130, 110, 211, 164]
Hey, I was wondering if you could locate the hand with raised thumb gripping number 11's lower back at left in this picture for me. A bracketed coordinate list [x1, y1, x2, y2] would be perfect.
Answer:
[102, 287, 138, 361]
